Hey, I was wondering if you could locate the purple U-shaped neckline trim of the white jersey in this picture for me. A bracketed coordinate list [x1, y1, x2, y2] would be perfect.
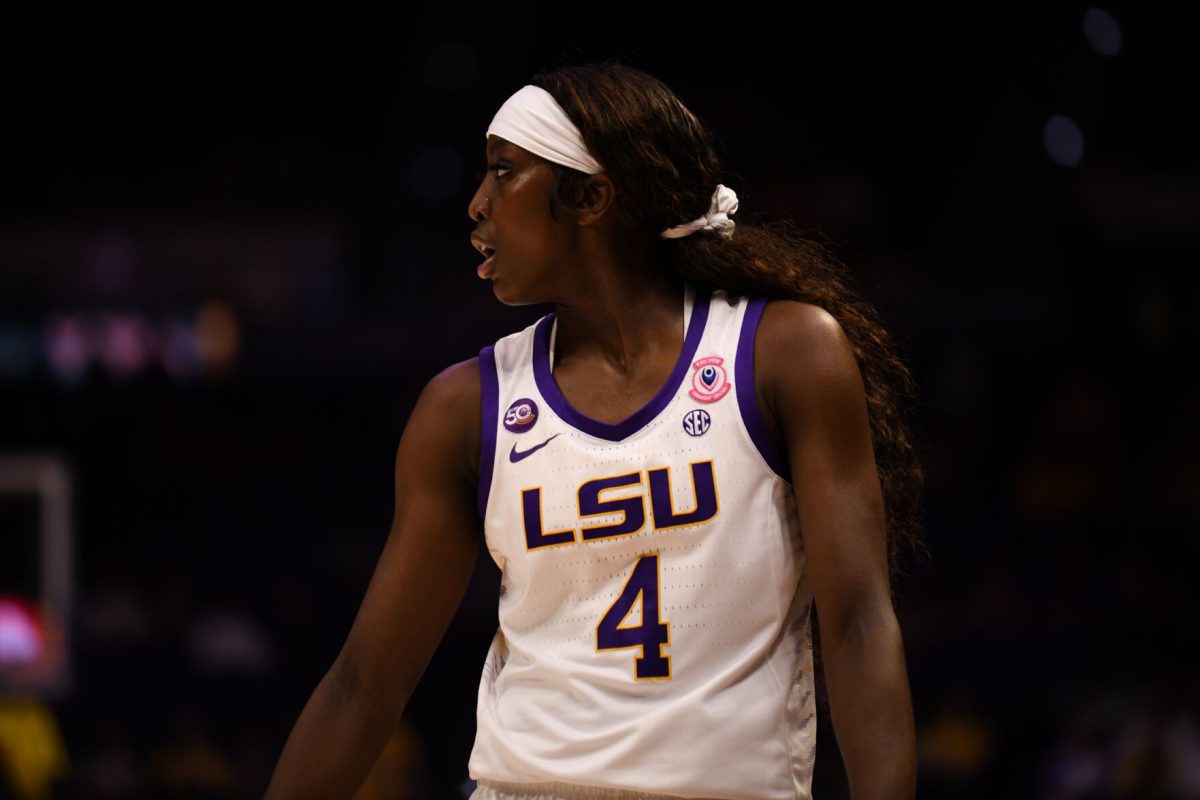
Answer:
[533, 286, 710, 441]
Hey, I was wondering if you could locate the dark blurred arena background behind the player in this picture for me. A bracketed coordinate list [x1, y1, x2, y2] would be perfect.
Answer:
[0, 2, 1200, 800]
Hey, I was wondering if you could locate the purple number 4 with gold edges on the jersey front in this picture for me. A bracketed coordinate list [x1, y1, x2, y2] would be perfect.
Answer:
[596, 553, 671, 680]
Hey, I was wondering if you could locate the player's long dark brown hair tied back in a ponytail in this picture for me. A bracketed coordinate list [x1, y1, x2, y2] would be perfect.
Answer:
[530, 60, 925, 590]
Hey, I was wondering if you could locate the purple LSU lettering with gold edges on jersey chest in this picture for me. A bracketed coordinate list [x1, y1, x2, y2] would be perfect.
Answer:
[521, 459, 719, 551]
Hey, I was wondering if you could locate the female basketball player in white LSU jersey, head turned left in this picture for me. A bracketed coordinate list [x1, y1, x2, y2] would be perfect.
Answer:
[268, 62, 922, 800]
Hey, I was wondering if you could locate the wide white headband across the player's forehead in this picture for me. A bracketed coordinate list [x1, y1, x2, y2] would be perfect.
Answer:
[485, 84, 604, 175]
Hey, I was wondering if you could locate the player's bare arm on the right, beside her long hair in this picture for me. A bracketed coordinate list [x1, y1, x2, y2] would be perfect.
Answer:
[755, 300, 917, 800]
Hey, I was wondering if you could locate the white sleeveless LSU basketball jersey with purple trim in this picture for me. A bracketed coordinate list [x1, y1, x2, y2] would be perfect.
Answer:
[470, 285, 816, 799]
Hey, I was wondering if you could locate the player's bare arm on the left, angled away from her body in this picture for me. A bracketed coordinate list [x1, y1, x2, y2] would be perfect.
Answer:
[266, 359, 481, 800]
